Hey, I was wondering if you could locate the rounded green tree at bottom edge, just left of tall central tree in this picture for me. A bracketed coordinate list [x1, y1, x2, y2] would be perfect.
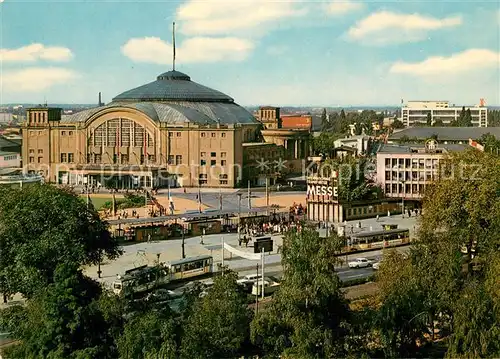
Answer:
[181, 271, 250, 359]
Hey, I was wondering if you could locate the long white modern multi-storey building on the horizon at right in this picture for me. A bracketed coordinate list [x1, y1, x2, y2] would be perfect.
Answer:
[401, 99, 488, 127]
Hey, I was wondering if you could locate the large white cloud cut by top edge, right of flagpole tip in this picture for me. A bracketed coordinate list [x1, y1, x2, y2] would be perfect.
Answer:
[177, 0, 308, 35]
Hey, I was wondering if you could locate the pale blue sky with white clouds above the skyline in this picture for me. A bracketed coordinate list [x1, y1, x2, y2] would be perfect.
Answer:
[0, 0, 500, 107]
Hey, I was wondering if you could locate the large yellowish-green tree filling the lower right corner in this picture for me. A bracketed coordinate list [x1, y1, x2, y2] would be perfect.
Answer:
[379, 150, 500, 358]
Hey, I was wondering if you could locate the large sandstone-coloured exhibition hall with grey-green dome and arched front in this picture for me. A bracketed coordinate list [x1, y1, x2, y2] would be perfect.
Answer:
[23, 71, 281, 188]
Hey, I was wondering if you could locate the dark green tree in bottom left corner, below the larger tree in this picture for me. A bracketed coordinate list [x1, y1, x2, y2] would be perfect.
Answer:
[2, 264, 115, 359]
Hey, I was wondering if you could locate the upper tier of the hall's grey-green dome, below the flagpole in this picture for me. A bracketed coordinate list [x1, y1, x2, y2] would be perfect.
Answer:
[113, 70, 234, 103]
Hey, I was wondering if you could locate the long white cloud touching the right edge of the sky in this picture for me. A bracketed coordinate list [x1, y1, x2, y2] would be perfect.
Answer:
[389, 49, 500, 76]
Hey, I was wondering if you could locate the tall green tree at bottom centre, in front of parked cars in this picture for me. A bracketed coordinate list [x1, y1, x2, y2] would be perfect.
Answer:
[251, 227, 350, 358]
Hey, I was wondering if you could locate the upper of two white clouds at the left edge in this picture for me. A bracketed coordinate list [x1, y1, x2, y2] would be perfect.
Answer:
[0, 44, 73, 62]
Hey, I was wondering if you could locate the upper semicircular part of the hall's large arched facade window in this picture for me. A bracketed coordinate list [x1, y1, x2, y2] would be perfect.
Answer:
[90, 118, 154, 147]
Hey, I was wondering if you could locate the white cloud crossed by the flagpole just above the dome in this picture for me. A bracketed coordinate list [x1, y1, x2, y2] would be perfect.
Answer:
[122, 37, 255, 65]
